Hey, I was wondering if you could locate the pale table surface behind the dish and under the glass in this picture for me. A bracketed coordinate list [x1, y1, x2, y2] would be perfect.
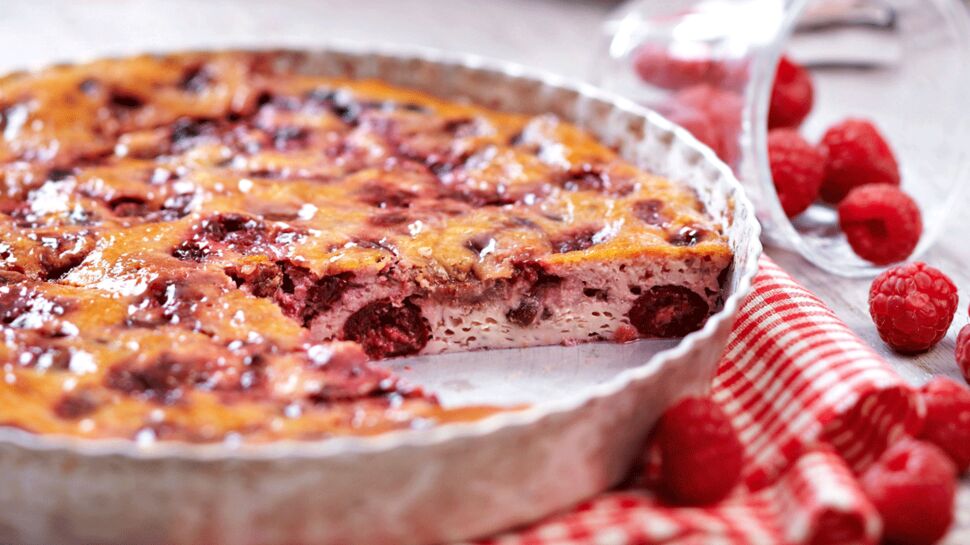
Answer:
[0, 0, 970, 545]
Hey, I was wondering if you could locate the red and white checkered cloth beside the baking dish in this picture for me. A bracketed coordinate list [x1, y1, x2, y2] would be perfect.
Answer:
[483, 258, 922, 545]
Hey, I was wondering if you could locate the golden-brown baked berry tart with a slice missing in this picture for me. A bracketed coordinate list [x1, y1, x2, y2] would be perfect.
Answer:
[0, 53, 732, 441]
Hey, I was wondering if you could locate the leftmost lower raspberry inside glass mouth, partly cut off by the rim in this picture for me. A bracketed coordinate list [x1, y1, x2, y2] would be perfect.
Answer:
[768, 129, 825, 218]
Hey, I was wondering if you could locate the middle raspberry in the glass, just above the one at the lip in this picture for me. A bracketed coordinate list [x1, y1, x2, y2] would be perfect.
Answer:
[821, 119, 899, 203]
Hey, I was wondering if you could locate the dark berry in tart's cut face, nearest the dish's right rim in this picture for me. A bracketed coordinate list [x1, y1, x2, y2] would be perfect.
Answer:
[627, 285, 710, 337]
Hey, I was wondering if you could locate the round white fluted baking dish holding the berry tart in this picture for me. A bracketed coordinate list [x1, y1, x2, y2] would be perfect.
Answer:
[0, 47, 761, 545]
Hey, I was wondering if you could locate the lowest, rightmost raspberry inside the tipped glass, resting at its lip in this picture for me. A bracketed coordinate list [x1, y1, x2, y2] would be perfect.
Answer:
[839, 184, 923, 265]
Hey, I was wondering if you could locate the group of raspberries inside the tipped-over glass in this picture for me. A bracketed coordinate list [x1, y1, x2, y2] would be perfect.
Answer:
[632, 44, 923, 265]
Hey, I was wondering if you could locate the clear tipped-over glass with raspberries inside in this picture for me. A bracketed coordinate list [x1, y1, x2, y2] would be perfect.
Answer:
[593, 0, 970, 276]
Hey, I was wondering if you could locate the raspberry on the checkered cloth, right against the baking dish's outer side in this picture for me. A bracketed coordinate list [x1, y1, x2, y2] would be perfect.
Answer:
[655, 398, 744, 505]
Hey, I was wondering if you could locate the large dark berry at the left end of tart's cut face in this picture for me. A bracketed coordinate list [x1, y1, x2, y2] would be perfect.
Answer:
[343, 299, 431, 359]
